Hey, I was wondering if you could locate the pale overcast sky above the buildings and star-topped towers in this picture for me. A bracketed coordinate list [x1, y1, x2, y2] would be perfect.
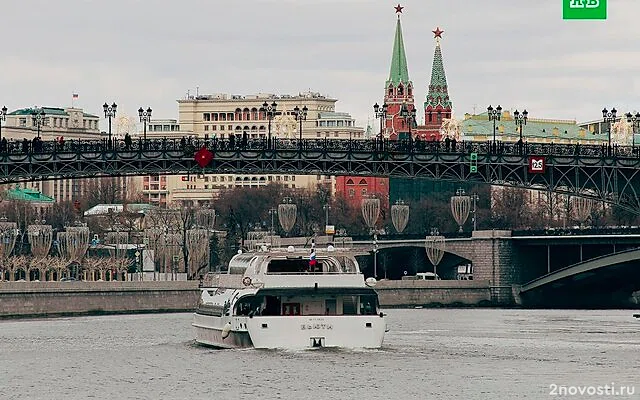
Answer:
[0, 0, 640, 130]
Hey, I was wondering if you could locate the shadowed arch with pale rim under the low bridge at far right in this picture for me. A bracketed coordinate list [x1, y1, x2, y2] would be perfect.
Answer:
[520, 248, 640, 307]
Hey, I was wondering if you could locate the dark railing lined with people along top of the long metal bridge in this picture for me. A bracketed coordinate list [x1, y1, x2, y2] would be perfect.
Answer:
[0, 137, 640, 158]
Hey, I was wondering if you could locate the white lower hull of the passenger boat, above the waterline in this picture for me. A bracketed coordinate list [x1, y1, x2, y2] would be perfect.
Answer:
[193, 314, 386, 349]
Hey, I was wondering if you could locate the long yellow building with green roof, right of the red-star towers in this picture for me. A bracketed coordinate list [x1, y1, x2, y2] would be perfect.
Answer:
[461, 112, 608, 142]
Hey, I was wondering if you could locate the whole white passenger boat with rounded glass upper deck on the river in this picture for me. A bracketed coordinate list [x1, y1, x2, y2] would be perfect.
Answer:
[192, 247, 386, 349]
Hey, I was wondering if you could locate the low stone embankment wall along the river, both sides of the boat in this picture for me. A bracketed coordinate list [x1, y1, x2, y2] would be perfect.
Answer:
[0, 280, 500, 318]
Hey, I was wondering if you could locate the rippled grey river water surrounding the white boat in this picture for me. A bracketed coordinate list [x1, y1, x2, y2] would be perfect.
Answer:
[0, 309, 640, 400]
